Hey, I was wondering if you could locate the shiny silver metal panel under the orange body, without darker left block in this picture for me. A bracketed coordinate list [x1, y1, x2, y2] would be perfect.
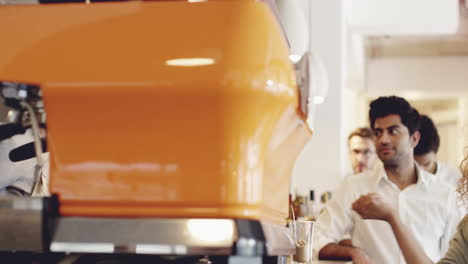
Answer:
[50, 217, 294, 256]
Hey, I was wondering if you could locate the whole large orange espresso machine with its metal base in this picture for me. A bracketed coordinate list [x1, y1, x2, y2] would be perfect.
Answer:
[0, 0, 311, 263]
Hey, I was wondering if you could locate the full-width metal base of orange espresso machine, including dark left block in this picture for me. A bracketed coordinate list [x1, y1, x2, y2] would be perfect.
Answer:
[0, 196, 295, 264]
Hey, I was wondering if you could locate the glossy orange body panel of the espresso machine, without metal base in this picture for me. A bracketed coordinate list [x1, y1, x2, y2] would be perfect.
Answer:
[0, 1, 311, 223]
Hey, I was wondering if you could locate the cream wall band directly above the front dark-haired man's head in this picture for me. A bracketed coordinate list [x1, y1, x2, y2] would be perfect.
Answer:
[366, 57, 468, 97]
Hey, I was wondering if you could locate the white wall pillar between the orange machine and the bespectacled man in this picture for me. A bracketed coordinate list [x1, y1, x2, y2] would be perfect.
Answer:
[291, 0, 346, 200]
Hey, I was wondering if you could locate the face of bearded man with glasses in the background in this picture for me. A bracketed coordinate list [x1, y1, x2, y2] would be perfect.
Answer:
[348, 127, 377, 174]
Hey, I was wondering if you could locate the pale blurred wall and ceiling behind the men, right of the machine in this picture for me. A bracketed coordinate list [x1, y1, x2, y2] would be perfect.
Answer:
[287, 0, 468, 199]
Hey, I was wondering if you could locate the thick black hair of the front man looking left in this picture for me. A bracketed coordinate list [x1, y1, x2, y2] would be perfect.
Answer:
[369, 96, 421, 135]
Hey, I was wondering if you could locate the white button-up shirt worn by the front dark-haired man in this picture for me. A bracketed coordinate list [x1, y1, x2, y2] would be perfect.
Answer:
[314, 164, 464, 264]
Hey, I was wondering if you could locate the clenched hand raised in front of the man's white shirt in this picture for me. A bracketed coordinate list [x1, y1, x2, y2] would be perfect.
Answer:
[353, 193, 396, 222]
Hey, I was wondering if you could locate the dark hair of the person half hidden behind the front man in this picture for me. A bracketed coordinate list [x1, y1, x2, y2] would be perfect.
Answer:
[414, 115, 440, 155]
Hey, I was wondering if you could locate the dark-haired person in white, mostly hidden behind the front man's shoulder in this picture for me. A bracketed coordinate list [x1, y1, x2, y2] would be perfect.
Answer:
[414, 115, 462, 187]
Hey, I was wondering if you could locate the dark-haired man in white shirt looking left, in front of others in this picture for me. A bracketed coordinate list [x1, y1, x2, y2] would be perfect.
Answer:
[314, 96, 461, 264]
